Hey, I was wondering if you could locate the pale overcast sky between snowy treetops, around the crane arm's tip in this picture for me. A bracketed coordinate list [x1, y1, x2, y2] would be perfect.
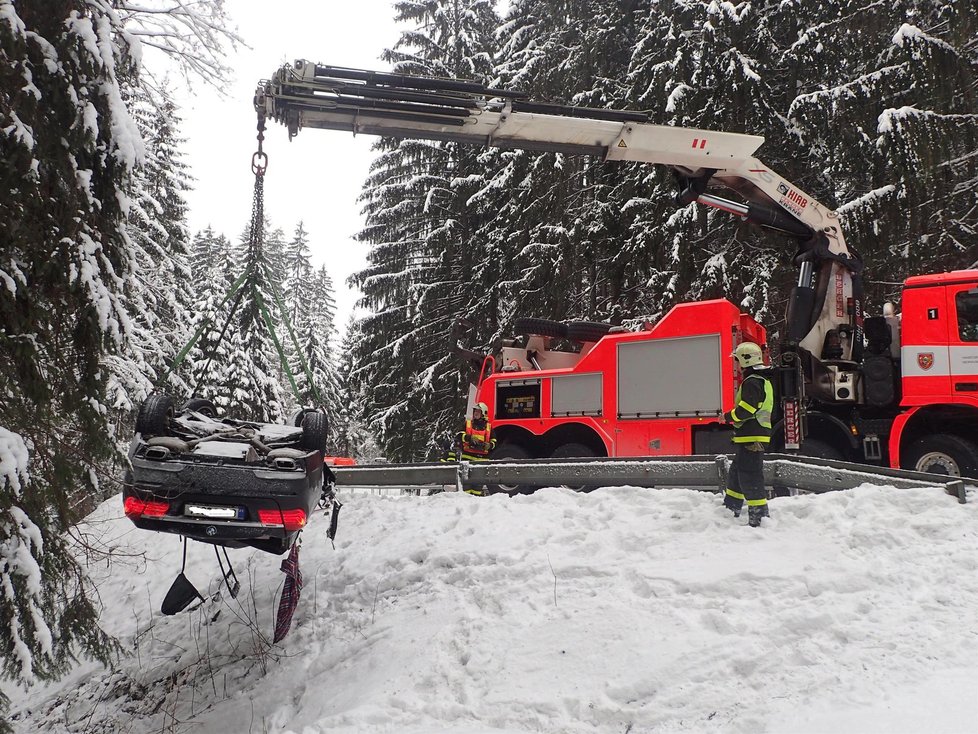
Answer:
[182, 0, 399, 329]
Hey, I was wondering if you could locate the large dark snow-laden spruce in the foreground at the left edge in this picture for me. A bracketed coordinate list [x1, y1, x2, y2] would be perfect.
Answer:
[0, 0, 135, 712]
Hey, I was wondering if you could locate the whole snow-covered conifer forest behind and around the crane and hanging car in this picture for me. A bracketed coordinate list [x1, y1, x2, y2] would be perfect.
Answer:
[0, 0, 978, 723]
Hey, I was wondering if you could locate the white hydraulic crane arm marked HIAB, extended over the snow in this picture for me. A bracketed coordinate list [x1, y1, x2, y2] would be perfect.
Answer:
[255, 61, 862, 366]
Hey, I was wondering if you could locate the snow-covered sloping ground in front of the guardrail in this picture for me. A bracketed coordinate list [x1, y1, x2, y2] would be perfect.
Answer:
[8, 486, 978, 734]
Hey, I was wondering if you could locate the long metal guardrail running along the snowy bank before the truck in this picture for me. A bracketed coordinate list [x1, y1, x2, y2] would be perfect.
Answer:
[333, 454, 978, 503]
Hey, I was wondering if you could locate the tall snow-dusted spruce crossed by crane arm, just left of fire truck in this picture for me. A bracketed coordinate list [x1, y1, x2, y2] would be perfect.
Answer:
[353, 0, 498, 460]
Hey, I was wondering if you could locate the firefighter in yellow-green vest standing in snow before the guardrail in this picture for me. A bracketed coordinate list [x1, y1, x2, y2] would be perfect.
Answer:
[723, 342, 774, 528]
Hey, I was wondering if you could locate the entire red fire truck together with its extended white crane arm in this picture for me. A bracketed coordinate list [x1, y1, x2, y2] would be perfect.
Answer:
[255, 61, 978, 488]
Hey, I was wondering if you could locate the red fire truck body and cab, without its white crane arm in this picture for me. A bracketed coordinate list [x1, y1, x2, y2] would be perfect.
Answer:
[464, 270, 978, 476]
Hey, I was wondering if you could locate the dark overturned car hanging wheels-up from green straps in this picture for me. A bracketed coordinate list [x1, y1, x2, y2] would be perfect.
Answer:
[122, 394, 331, 554]
